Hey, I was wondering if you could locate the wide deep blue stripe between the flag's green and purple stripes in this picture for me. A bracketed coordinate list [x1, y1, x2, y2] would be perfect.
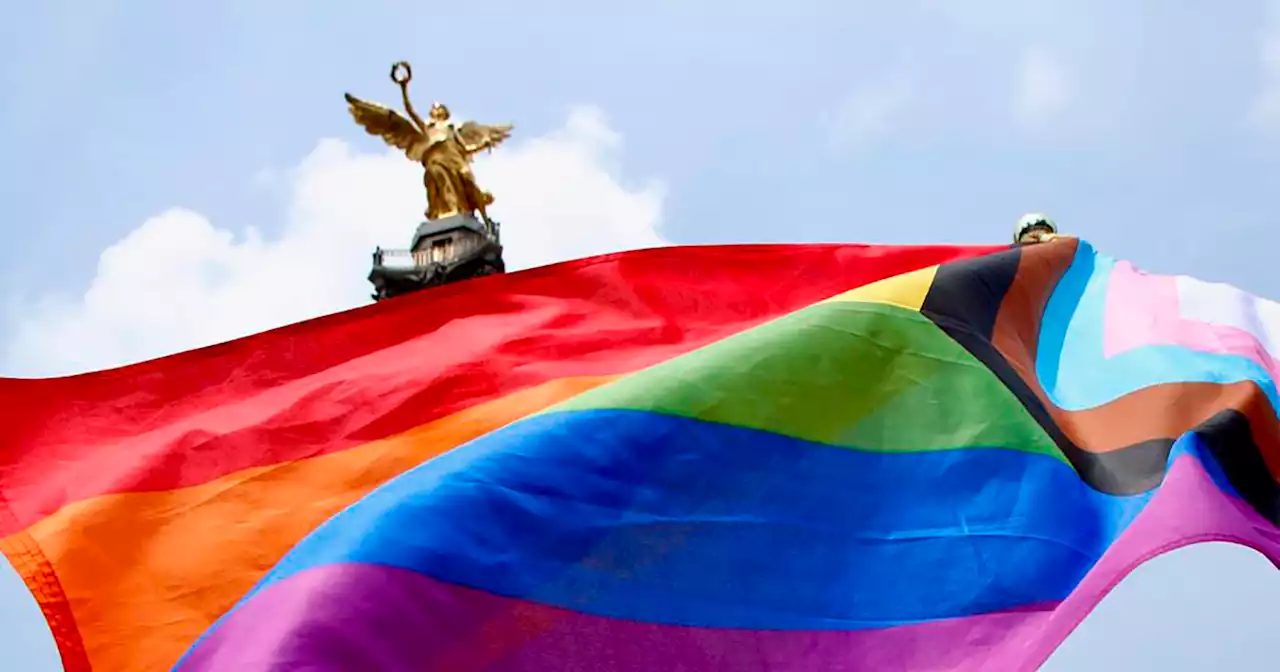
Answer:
[222, 411, 1149, 630]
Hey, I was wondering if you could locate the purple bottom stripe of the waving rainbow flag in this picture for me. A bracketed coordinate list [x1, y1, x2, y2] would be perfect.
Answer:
[182, 456, 1280, 672]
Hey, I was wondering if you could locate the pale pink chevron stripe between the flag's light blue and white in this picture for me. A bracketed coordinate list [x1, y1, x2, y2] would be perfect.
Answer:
[1102, 261, 1280, 375]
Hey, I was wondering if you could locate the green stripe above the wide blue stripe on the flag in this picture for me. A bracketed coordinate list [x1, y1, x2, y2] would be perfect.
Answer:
[545, 302, 1065, 461]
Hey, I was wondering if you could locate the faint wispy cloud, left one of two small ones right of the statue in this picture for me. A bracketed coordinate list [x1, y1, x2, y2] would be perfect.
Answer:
[827, 72, 915, 151]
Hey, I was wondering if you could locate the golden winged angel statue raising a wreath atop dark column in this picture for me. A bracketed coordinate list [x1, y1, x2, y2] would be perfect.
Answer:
[346, 61, 512, 225]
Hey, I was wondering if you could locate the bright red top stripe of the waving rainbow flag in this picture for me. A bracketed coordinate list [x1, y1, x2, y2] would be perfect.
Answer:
[0, 244, 1002, 534]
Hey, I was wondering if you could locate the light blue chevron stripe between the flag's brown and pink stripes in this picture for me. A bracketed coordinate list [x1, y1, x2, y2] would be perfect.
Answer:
[1036, 241, 1280, 411]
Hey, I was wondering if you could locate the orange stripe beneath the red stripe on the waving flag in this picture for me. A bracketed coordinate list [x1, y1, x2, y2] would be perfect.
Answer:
[0, 376, 614, 671]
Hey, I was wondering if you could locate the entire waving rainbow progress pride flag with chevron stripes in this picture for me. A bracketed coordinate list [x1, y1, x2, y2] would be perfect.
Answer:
[0, 238, 1280, 672]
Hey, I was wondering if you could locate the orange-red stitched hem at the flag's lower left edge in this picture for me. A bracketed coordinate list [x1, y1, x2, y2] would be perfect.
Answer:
[0, 492, 92, 672]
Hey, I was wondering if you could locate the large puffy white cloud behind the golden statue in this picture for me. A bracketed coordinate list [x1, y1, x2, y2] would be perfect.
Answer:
[4, 109, 666, 375]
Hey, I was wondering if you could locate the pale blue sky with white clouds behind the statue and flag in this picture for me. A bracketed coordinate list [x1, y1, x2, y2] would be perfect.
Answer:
[0, 0, 1280, 672]
